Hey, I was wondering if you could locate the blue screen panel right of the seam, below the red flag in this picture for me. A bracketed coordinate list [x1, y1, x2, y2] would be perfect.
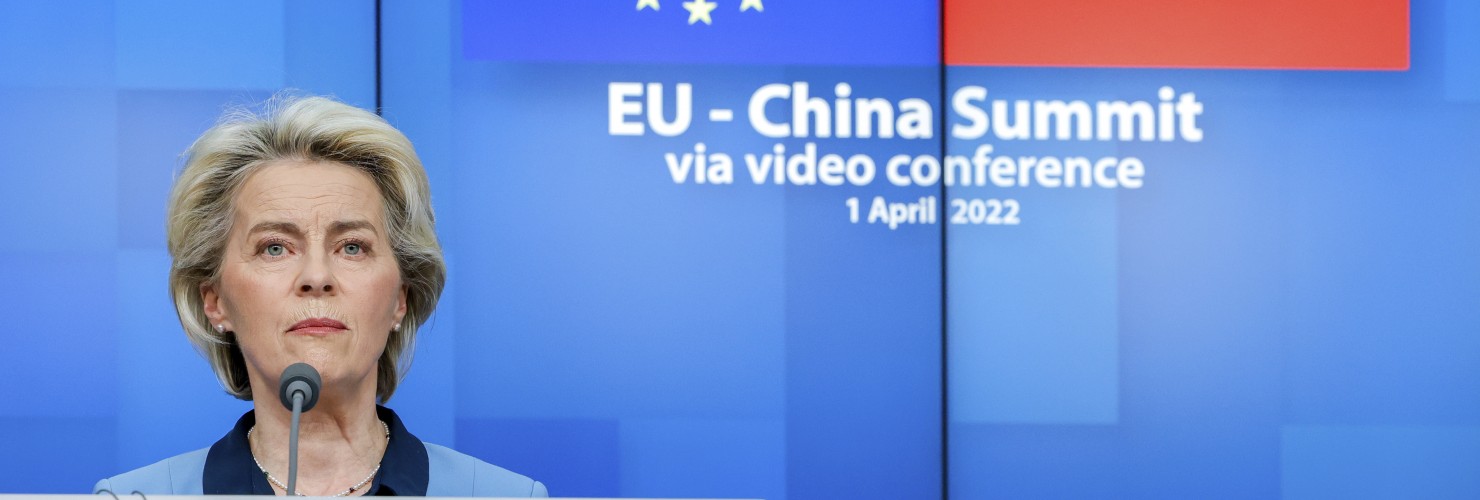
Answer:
[947, 3, 1480, 499]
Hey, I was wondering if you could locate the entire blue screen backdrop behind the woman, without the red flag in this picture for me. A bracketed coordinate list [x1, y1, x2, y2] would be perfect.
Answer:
[0, 0, 1480, 499]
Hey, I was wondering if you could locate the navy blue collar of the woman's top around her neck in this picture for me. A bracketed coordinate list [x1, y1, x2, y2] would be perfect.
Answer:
[201, 405, 429, 497]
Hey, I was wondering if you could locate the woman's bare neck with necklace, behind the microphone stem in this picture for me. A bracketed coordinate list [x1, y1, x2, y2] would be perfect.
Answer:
[252, 391, 389, 496]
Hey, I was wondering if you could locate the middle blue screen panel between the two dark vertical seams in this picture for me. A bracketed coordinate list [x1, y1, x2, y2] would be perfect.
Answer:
[385, 1, 941, 499]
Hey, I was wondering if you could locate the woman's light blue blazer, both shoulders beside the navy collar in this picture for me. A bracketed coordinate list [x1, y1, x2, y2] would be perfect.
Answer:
[93, 442, 549, 497]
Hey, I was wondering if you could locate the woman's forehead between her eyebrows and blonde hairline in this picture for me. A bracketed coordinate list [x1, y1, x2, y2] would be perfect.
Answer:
[235, 161, 383, 231]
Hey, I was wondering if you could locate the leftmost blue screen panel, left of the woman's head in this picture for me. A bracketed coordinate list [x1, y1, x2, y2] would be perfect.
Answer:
[0, 1, 374, 493]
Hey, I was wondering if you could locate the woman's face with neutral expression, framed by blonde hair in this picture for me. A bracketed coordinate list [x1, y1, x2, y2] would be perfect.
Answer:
[201, 161, 406, 396]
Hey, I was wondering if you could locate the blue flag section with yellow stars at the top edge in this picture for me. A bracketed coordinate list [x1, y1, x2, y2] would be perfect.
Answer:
[462, 0, 940, 67]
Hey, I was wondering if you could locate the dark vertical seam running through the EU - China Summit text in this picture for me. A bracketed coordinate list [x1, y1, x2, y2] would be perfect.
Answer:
[937, 0, 950, 500]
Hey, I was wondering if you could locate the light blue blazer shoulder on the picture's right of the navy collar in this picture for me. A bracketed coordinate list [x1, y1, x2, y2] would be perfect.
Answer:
[422, 442, 549, 497]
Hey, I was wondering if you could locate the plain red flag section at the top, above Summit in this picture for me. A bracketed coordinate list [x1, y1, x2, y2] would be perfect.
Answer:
[944, 0, 1409, 70]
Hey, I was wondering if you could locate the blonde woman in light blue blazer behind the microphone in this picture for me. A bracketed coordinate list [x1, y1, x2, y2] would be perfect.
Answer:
[95, 98, 546, 497]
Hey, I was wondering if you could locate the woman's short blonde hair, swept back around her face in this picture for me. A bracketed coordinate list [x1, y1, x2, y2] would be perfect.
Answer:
[166, 95, 447, 402]
